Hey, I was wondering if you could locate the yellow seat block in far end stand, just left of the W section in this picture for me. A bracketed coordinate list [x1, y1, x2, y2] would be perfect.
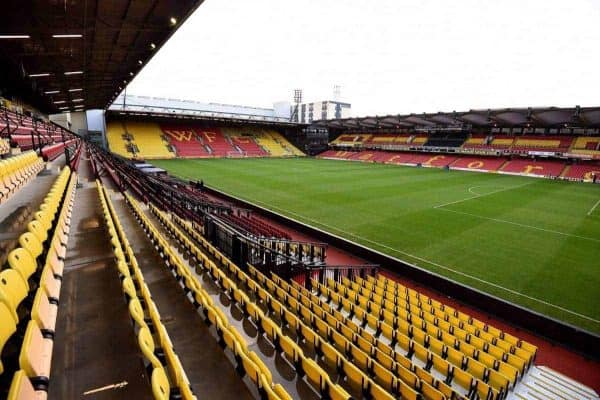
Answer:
[124, 122, 175, 158]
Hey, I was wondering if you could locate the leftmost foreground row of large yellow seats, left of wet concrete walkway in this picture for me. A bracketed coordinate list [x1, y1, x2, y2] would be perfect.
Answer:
[0, 167, 77, 400]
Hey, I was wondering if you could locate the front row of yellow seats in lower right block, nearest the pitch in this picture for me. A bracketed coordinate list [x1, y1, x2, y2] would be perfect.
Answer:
[364, 275, 537, 365]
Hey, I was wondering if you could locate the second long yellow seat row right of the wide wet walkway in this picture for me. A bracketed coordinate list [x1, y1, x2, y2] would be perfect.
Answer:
[127, 196, 298, 400]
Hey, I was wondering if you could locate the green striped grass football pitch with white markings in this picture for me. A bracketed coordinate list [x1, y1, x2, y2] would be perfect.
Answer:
[155, 158, 600, 333]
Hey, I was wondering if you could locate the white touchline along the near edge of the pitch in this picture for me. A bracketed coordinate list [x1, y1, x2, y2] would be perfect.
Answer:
[220, 192, 600, 323]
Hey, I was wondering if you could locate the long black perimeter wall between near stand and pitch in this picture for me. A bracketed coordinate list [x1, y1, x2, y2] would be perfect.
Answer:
[205, 186, 600, 360]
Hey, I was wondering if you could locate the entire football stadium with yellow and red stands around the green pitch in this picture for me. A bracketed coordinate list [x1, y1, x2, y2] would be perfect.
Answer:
[0, 0, 600, 400]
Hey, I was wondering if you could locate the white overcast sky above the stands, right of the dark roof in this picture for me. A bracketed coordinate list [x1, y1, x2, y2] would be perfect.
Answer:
[128, 0, 600, 116]
